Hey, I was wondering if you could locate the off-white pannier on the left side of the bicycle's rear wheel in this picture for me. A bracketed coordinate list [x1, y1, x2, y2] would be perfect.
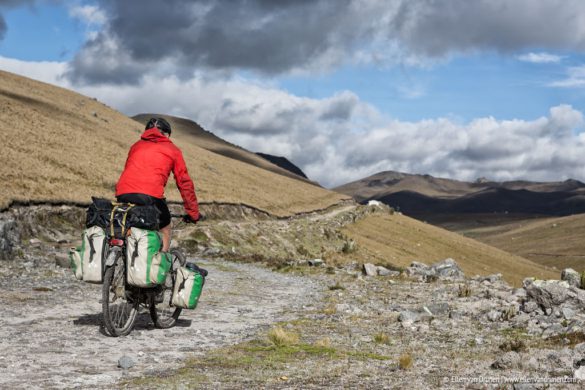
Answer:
[80, 226, 106, 283]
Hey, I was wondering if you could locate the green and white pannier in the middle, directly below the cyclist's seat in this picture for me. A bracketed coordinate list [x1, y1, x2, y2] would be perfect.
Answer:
[126, 227, 171, 287]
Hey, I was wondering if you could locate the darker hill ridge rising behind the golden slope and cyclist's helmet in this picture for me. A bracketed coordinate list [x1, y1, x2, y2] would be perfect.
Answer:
[132, 114, 315, 184]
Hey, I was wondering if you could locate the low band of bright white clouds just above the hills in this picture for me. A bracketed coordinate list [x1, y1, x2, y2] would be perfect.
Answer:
[0, 57, 585, 186]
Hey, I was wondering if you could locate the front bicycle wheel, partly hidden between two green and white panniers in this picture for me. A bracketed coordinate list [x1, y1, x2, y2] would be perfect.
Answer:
[150, 249, 187, 329]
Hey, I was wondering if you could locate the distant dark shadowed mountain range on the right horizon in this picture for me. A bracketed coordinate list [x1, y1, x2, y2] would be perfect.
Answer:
[334, 171, 585, 215]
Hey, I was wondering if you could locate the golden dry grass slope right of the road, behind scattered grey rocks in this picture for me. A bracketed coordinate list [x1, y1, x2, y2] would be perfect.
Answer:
[343, 214, 559, 285]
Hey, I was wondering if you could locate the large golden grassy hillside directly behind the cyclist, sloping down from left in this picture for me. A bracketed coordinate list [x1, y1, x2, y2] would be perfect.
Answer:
[0, 72, 348, 216]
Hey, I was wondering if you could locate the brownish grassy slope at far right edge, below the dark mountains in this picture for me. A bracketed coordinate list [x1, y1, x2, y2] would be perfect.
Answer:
[465, 214, 585, 271]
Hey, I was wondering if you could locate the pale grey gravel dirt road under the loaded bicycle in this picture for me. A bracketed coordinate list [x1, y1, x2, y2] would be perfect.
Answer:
[0, 259, 324, 389]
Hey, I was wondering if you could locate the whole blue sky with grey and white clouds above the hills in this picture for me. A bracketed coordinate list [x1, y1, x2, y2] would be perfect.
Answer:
[0, 0, 585, 187]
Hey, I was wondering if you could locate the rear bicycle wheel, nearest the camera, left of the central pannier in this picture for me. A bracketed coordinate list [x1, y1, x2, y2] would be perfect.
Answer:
[102, 266, 140, 337]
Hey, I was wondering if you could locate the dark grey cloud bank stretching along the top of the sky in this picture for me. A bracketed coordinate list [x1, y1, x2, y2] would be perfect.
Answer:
[65, 0, 585, 84]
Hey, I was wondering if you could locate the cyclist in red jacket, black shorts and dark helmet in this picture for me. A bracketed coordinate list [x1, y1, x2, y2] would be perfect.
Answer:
[116, 118, 200, 252]
